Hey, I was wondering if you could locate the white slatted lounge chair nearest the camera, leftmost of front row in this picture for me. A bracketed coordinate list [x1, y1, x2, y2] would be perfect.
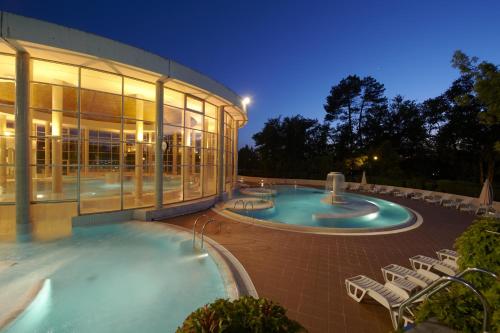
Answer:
[345, 275, 413, 328]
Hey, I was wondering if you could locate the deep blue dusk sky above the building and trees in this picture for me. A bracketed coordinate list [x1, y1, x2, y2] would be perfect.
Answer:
[0, 0, 500, 147]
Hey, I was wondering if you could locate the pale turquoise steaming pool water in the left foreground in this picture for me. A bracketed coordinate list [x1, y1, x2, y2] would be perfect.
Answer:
[0, 223, 228, 333]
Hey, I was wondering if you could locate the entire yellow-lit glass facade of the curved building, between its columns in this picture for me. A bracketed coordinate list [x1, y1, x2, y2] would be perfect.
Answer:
[0, 54, 242, 223]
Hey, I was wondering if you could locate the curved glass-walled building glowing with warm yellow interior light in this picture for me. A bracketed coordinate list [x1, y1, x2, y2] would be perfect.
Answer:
[0, 12, 247, 237]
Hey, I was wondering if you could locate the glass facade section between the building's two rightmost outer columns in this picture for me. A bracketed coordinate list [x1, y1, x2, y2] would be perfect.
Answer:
[163, 89, 217, 203]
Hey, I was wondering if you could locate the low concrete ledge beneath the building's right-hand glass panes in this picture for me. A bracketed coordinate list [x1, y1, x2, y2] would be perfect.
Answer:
[131, 196, 217, 221]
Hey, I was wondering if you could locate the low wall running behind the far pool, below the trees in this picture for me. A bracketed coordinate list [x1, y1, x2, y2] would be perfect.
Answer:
[237, 176, 500, 211]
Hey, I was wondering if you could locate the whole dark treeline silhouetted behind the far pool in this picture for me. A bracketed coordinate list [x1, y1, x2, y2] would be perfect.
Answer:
[239, 51, 500, 195]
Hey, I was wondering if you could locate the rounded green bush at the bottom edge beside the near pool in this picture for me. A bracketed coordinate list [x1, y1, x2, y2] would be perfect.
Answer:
[176, 296, 306, 333]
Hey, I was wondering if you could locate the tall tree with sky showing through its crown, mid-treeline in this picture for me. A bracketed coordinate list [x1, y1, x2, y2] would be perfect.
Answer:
[323, 75, 387, 151]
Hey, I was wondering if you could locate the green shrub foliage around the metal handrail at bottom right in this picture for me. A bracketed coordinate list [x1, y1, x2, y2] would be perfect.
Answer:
[417, 218, 500, 332]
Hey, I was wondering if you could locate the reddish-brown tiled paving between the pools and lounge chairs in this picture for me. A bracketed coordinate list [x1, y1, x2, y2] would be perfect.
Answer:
[162, 192, 473, 333]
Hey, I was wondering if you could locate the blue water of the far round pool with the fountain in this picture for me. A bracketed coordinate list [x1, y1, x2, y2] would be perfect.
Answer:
[232, 186, 412, 228]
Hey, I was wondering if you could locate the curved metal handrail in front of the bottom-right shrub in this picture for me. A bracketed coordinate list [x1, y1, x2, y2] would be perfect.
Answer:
[396, 276, 489, 333]
